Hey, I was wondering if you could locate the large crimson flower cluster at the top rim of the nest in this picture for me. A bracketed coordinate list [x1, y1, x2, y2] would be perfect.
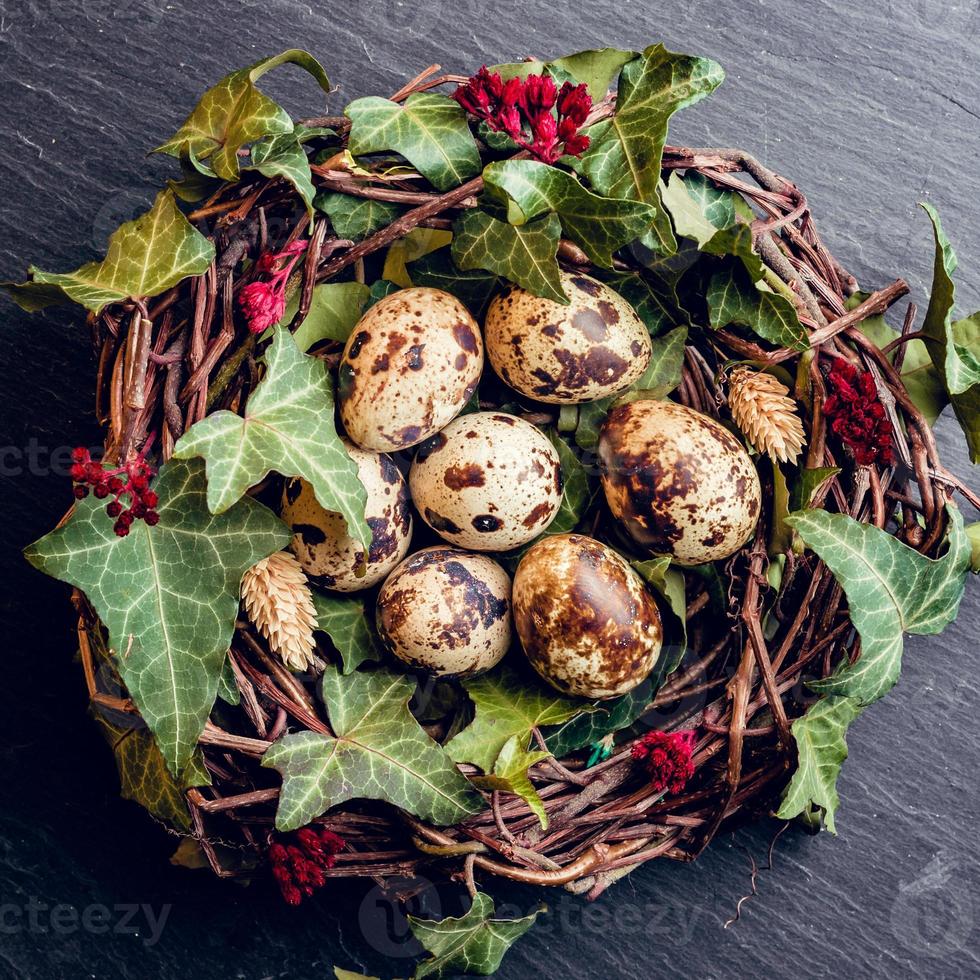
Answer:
[453, 65, 592, 163]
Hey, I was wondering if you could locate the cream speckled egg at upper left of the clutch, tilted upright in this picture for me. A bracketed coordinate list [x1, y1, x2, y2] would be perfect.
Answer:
[338, 288, 483, 452]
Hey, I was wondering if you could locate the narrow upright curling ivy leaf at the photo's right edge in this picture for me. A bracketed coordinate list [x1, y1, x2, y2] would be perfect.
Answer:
[922, 204, 980, 463]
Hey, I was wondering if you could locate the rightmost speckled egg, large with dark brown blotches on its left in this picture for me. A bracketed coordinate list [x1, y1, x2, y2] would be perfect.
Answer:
[599, 401, 762, 565]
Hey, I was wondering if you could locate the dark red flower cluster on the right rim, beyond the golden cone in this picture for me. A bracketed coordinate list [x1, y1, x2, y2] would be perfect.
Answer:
[823, 358, 894, 466]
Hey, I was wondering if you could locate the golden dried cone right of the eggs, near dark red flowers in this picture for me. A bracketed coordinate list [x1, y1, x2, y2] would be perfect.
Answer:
[728, 367, 806, 463]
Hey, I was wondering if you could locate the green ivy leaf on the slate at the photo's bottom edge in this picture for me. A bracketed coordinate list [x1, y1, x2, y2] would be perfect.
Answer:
[408, 892, 544, 980]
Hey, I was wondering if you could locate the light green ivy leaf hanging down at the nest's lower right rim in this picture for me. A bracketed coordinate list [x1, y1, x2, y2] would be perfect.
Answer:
[776, 697, 862, 834]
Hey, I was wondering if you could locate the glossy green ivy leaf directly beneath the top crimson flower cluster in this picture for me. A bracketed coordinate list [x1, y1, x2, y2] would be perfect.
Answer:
[483, 160, 657, 269]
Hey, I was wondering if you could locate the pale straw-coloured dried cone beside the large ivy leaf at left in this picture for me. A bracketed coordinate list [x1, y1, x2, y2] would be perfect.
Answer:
[242, 551, 316, 670]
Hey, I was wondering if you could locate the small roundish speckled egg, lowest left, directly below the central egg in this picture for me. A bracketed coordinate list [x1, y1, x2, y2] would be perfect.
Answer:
[378, 545, 511, 677]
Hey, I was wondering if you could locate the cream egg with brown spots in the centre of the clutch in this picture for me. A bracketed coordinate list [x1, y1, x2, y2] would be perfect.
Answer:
[408, 412, 562, 551]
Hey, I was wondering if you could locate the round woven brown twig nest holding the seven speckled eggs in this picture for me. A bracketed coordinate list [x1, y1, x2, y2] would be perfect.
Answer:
[11, 47, 967, 964]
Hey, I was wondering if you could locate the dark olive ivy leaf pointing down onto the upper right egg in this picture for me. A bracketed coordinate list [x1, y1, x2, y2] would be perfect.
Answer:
[452, 208, 568, 298]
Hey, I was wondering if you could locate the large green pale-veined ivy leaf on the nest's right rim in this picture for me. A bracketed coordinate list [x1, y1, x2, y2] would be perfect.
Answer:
[786, 504, 970, 705]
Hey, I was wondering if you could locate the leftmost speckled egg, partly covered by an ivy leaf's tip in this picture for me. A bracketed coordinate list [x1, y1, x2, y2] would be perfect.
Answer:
[282, 442, 412, 592]
